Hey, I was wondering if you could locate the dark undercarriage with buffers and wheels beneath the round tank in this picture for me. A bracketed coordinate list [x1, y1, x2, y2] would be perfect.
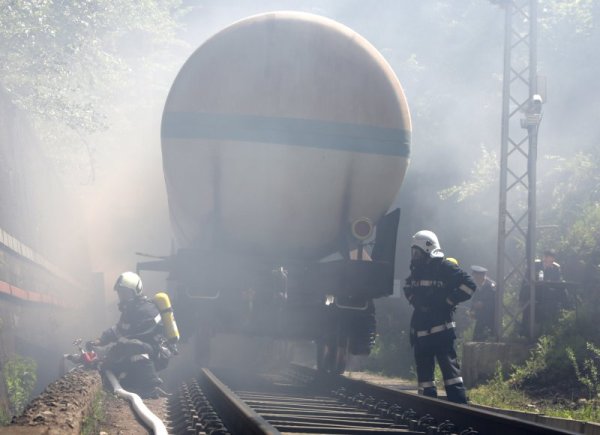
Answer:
[138, 209, 400, 373]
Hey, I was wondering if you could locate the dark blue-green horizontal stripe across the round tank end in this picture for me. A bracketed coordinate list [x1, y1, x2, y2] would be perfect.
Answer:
[161, 112, 411, 157]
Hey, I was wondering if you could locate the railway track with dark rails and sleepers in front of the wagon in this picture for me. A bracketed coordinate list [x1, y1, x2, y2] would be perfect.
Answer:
[168, 365, 574, 435]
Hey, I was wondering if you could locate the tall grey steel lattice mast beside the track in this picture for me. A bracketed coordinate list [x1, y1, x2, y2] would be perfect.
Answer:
[492, 0, 543, 341]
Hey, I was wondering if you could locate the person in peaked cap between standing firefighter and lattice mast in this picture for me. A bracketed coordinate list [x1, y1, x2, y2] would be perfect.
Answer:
[471, 266, 496, 341]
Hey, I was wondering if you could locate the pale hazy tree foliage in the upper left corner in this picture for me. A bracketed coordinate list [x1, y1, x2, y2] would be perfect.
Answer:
[0, 0, 181, 155]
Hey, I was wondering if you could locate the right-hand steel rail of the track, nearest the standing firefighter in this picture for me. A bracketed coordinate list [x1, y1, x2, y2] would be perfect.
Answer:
[290, 364, 576, 435]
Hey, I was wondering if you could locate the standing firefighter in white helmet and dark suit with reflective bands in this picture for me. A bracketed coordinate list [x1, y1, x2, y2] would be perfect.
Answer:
[404, 231, 477, 403]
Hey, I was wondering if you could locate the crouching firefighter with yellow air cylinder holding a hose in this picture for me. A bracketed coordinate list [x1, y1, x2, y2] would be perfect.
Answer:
[88, 272, 179, 398]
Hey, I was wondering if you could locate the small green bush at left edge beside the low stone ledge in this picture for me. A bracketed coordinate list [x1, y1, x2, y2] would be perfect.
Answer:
[2, 354, 37, 415]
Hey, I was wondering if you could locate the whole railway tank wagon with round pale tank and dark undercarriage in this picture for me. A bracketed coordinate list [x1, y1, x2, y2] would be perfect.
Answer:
[138, 12, 411, 371]
